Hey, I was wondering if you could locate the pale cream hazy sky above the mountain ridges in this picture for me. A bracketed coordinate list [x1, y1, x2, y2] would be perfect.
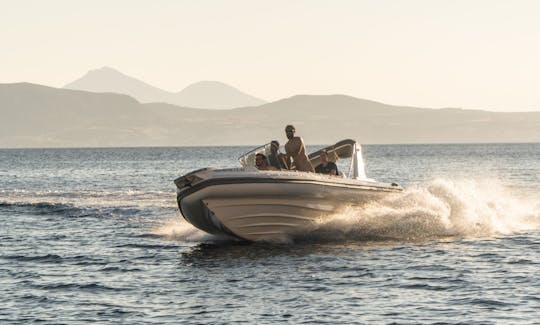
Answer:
[0, 0, 540, 111]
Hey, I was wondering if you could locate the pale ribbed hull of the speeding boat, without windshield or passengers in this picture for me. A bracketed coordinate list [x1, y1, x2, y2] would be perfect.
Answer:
[177, 173, 401, 241]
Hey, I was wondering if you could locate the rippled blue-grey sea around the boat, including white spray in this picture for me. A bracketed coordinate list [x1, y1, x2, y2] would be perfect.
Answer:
[0, 143, 540, 324]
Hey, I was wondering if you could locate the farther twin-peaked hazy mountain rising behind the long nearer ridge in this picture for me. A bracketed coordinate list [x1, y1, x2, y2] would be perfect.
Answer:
[64, 67, 265, 109]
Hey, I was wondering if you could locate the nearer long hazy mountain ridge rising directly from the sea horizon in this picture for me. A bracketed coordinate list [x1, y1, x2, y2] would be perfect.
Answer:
[0, 83, 540, 148]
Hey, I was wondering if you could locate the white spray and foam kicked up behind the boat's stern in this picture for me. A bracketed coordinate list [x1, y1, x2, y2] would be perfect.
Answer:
[317, 179, 540, 240]
